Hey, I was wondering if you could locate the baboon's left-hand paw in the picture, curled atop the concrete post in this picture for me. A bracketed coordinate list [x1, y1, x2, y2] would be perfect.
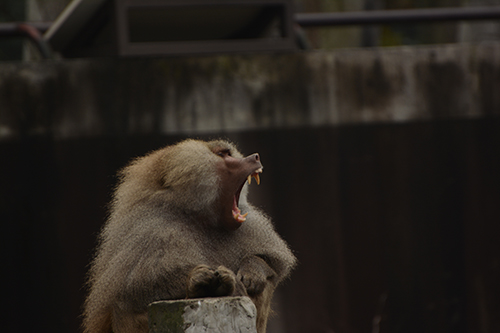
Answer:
[186, 265, 236, 298]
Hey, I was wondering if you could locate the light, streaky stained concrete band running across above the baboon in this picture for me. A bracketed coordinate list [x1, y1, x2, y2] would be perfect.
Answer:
[0, 43, 500, 139]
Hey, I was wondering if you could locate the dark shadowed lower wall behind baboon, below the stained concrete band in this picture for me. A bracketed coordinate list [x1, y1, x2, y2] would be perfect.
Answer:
[0, 118, 500, 333]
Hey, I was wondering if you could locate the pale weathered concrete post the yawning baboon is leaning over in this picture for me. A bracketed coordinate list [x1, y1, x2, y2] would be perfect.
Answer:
[148, 297, 257, 333]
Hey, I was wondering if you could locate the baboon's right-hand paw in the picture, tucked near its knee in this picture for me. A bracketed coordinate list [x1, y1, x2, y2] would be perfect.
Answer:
[236, 256, 276, 296]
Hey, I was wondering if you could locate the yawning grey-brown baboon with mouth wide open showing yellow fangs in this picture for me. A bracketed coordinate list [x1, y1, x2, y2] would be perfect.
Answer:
[83, 140, 296, 333]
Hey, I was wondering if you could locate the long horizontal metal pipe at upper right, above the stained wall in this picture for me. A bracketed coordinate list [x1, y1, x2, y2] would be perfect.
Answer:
[295, 6, 500, 27]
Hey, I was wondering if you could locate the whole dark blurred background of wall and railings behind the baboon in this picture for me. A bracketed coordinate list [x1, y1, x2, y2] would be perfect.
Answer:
[0, 0, 500, 333]
